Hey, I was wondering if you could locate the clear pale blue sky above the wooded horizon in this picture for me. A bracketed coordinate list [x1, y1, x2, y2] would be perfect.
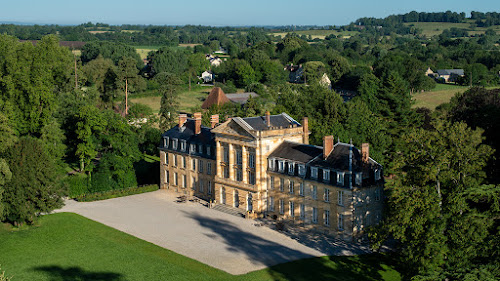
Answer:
[0, 0, 500, 26]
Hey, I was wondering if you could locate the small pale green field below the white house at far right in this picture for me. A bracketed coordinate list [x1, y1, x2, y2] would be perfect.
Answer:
[413, 84, 469, 110]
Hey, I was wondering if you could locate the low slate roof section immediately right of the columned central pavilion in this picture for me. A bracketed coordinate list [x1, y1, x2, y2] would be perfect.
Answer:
[269, 141, 323, 163]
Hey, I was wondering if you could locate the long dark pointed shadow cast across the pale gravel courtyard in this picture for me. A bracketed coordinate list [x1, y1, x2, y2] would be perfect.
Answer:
[185, 212, 313, 266]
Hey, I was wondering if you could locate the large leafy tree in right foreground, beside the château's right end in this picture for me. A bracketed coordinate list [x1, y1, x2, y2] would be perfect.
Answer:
[381, 121, 500, 280]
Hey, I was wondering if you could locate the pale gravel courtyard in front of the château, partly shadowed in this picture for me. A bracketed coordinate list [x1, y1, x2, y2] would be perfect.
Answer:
[57, 190, 367, 274]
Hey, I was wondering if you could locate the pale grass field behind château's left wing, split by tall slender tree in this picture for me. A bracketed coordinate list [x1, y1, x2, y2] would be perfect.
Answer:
[130, 86, 212, 113]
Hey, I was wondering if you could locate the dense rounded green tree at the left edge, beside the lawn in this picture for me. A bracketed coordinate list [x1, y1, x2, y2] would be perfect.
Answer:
[4, 137, 63, 225]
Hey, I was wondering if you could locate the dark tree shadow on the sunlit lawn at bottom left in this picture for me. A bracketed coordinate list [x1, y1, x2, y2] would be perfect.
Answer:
[33, 265, 125, 281]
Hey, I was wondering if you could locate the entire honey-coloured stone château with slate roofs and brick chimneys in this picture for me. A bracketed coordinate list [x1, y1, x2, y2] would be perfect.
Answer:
[159, 110, 383, 239]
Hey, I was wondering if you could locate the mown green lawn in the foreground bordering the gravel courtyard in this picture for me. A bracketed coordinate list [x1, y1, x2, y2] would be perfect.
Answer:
[0, 213, 401, 281]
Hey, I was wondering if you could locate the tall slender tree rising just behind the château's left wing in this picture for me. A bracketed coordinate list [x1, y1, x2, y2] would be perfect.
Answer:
[155, 72, 182, 131]
